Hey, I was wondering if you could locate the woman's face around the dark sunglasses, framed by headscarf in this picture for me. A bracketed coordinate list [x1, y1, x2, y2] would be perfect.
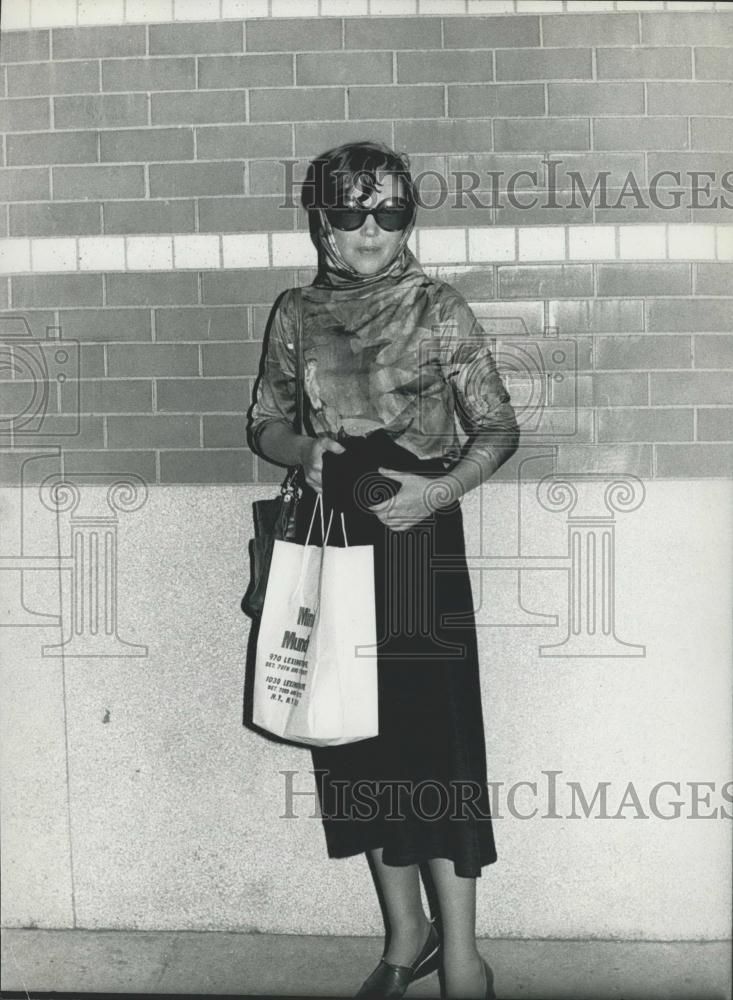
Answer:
[333, 173, 406, 274]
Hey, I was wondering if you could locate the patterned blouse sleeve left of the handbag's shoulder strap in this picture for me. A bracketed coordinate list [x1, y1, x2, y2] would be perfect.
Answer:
[247, 293, 296, 458]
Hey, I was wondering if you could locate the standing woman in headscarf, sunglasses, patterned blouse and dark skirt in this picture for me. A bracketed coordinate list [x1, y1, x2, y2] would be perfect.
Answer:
[250, 142, 519, 998]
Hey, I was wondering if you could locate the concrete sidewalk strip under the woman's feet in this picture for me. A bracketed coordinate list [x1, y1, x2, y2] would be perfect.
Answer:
[2, 928, 731, 1000]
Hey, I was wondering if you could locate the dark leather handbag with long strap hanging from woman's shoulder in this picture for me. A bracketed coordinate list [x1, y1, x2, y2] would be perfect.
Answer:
[241, 288, 305, 619]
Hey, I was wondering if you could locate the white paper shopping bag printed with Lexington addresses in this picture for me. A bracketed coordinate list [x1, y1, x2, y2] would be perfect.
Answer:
[253, 494, 379, 746]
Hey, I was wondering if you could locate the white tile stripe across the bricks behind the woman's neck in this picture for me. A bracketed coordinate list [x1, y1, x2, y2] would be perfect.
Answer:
[0, 224, 733, 275]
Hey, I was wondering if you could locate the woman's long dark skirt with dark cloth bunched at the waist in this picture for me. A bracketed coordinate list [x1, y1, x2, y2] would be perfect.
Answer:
[297, 431, 497, 877]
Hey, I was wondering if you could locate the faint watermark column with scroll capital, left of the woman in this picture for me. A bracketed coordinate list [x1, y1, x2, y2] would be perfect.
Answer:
[40, 473, 148, 657]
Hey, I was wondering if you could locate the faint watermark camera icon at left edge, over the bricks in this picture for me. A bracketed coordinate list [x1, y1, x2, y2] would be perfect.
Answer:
[0, 316, 80, 439]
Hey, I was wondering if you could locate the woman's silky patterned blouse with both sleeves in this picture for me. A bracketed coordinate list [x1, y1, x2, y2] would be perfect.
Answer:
[250, 248, 519, 465]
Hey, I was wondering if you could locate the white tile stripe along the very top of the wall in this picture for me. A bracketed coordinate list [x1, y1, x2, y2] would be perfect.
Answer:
[0, 0, 731, 31]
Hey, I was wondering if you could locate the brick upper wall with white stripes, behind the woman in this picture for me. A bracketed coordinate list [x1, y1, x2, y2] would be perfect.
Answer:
[0, 0, 733, 483]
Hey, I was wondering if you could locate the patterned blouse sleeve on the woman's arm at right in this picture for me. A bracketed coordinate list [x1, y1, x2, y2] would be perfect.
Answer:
[434, 291, 519, 468]
